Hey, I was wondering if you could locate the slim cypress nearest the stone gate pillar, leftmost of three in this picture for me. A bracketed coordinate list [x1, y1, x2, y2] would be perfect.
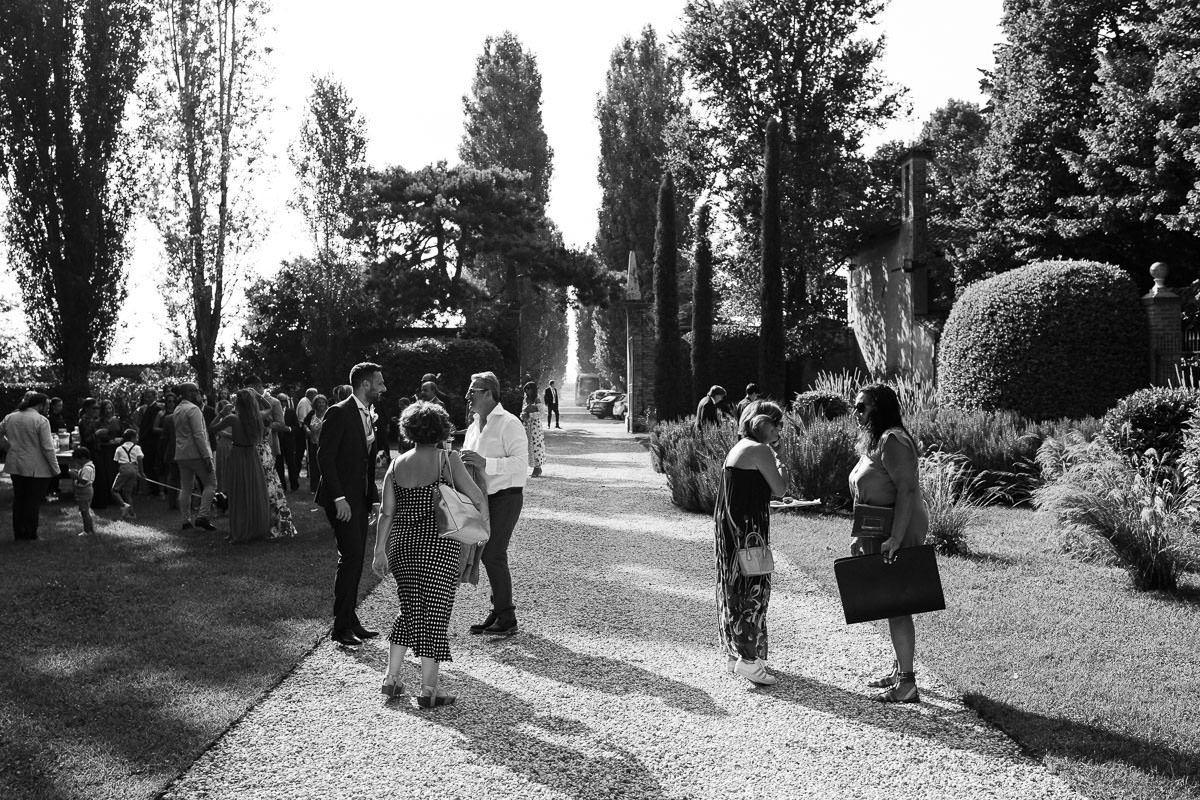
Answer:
[654, 172, 684, 420]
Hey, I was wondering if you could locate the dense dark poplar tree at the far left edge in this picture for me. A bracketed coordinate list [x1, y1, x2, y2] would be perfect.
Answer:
[0, 0, 149, 395]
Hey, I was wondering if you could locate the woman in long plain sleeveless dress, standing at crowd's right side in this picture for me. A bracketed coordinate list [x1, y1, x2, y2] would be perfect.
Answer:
[212, 389, 271, 545]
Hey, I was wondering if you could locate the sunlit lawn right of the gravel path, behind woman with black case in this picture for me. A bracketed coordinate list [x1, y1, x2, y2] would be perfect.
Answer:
[772, 509, 1200, 800]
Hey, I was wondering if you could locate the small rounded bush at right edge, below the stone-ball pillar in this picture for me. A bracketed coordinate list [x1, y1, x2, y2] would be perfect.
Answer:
[1102, 386, 1200, 459]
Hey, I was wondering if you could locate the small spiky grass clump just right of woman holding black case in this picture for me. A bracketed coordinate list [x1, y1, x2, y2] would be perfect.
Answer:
[920, 450, 988, 555]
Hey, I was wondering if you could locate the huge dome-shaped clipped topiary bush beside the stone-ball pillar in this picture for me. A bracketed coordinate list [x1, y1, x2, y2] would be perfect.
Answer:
[937, 261, 1150, 420]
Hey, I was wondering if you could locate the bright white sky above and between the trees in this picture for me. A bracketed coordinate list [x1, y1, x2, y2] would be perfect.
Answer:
[4, 0, 1002, 362]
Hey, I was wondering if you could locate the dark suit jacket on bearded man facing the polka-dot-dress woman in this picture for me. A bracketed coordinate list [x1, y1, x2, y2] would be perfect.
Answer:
[316, 395, 379, 509]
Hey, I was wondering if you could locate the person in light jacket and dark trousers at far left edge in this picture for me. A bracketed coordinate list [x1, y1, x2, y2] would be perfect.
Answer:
[0, 392, 61, 540]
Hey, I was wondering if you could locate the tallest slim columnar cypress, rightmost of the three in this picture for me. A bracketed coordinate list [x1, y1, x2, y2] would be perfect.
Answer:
[758, 119, 787, 399]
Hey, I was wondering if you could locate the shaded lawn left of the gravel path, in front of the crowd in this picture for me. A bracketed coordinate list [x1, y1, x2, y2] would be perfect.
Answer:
[0, 482, 376, 800]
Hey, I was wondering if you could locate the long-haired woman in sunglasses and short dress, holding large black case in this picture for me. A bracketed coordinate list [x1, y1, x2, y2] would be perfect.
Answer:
[850, 384, 929, 703]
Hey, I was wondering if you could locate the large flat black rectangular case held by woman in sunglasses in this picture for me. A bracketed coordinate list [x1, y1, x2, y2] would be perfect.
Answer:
[833, 545, 946, 625]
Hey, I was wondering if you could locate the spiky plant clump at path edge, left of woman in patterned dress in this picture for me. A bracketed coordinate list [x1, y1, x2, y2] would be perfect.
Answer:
[650, 417, 738, 513]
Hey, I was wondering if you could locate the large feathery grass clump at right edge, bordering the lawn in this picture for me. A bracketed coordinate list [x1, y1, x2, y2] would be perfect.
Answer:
[1033, 434, 1198, 591]
